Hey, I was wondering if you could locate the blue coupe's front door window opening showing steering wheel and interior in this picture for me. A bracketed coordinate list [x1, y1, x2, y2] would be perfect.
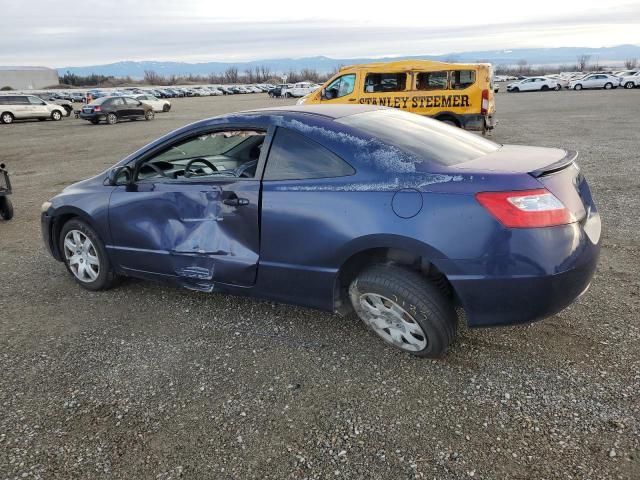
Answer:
[136, 130, 266, 181]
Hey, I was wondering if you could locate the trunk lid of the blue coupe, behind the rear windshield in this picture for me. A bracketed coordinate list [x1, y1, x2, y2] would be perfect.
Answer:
[453, 145, 577, 176]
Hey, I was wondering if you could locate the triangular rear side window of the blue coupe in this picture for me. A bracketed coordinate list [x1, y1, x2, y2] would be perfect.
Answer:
[264, 128, 355, 180]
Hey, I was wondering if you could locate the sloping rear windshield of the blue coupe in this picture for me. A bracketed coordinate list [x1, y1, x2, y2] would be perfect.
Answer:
[336, 109, 500, 165]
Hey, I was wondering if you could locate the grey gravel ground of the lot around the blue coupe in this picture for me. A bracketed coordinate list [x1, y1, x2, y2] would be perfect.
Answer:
[0, 89, 640, 479]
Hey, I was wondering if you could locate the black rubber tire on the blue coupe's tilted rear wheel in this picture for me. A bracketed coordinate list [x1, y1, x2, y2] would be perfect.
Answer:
[349, 265, 458, 358]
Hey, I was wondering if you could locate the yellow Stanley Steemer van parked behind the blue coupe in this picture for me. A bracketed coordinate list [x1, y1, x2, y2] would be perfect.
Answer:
[298, 60, 495, 132]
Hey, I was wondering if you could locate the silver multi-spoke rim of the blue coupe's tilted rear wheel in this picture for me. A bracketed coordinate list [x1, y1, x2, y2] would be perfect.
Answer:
[358, 293, 427, 352]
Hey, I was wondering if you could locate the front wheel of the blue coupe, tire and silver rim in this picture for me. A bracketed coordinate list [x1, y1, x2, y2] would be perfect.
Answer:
[59, 218, 116, 291]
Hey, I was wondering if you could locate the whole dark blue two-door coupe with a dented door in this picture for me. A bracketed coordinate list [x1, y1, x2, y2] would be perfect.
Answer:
[42, 105, 600, 357]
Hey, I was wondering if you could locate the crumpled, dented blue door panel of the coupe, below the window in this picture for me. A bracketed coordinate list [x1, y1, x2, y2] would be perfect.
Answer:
[108, 178, 260, 291]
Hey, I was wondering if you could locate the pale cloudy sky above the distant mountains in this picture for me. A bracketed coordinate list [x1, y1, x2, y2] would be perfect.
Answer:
[0, 0, 640, 67]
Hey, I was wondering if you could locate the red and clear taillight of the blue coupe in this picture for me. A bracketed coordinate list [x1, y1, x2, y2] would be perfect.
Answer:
[476, 188, 576, 228]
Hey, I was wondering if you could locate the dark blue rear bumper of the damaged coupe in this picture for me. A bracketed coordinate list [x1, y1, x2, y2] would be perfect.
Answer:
[447, 213, 600, 327]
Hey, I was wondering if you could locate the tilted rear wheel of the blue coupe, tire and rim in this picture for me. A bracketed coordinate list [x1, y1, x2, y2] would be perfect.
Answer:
[349, 265, 457, 357]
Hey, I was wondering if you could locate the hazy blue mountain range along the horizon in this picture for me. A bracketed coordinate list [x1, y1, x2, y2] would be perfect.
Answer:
[57, 45, 640, 78]
